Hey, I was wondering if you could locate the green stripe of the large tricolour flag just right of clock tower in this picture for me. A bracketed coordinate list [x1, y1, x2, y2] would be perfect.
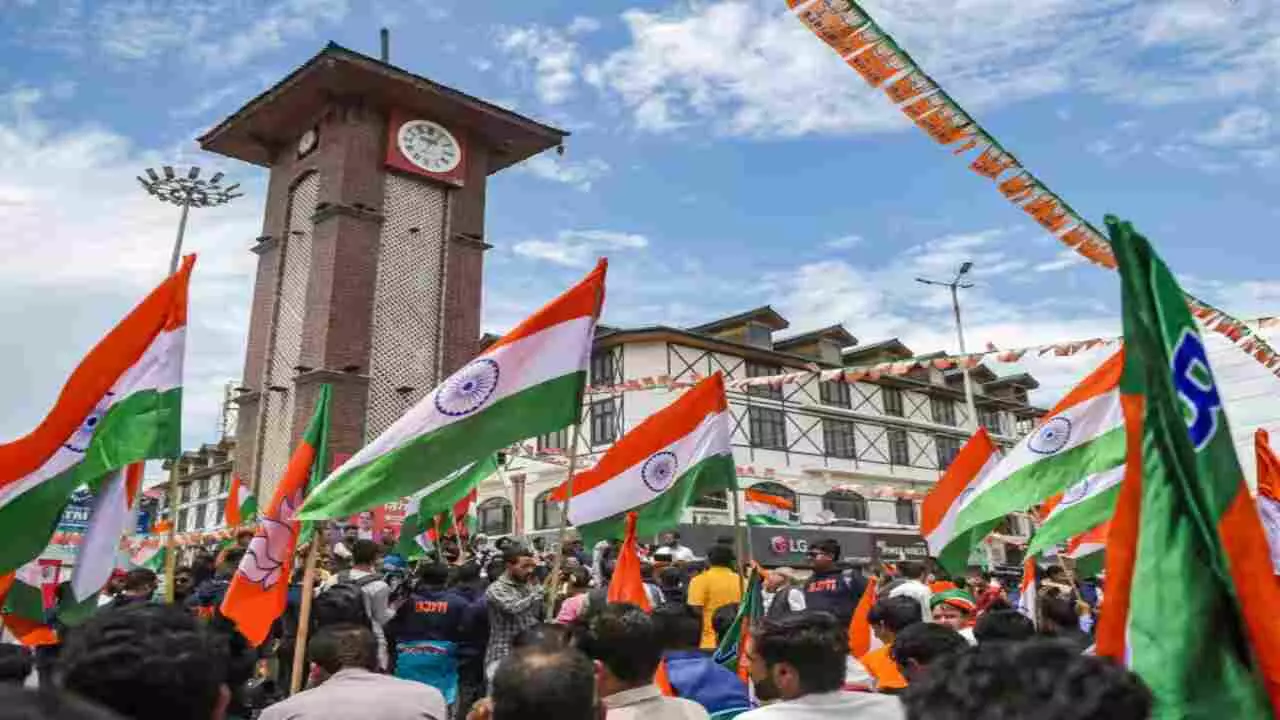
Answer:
[300, 372, 586, 520]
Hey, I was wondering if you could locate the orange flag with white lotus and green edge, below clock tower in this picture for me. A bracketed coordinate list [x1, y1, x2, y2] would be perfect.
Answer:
[221, 384, 330, 647]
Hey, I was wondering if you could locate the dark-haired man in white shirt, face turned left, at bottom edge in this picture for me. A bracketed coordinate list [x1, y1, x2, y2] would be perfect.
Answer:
[739, 612, 905, 720]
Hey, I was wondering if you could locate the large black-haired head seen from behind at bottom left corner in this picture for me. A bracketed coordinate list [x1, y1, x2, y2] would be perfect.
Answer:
[56, 603, 227, 720]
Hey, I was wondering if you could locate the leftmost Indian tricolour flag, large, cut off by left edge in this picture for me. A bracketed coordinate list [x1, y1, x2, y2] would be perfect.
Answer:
[0, 256, 195, 574]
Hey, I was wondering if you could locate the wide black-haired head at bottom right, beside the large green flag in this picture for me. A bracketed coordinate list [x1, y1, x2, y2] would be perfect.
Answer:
[900, 641, 1152, 720]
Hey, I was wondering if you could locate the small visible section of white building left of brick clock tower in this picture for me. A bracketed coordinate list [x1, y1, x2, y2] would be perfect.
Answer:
[157, 438, 236, 533]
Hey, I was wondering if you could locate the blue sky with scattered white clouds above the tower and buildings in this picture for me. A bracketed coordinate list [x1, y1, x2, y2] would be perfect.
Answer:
[0, 0, 1280, 474]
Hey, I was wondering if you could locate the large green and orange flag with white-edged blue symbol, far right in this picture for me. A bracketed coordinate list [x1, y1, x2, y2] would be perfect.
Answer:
[1098, 217, 1280, 719]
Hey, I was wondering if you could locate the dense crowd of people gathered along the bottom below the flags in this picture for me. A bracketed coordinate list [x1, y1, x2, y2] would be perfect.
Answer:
[0, 520, 1152, 720]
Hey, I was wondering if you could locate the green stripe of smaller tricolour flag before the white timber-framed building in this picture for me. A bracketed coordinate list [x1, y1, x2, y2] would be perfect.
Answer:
[577, 455, 737, 547]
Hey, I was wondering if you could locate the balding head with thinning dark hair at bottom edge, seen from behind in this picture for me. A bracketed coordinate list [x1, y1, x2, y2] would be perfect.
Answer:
[490, 648, 595, 720]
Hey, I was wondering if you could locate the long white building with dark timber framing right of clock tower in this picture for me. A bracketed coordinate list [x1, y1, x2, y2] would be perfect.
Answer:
[477, 306, 1043, 565]
